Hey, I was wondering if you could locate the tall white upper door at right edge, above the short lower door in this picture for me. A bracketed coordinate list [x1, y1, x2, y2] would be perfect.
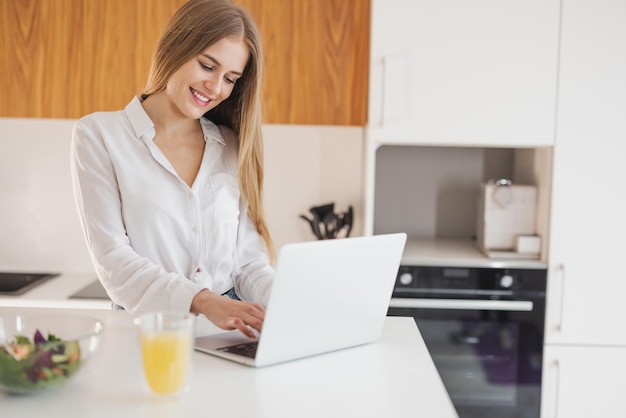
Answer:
[546, 0, 626, 346]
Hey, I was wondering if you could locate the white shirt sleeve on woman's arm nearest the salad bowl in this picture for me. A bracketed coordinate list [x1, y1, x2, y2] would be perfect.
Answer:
[71, 113, 202, 313]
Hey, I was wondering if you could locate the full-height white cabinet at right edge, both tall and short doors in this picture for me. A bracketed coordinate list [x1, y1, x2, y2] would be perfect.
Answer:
[542, 0, 626, 418]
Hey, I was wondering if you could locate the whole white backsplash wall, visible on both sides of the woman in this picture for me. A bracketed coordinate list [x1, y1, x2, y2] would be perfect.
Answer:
[0, 118, 363, 272]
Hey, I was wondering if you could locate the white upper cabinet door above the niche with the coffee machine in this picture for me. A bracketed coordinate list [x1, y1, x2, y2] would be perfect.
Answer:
[369, 0, 559, 146]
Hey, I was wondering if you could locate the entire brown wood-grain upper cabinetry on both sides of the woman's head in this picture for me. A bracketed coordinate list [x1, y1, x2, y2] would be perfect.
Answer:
[0, 0, 370, 126]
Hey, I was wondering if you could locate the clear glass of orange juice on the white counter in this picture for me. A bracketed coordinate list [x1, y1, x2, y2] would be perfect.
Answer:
[141, 331, 191, 394]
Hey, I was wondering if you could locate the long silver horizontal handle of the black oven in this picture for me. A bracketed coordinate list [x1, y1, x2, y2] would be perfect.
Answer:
[389, 298, 533, 312]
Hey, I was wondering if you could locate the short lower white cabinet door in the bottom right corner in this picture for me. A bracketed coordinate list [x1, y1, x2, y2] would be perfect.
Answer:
[541, 346, 626, 418]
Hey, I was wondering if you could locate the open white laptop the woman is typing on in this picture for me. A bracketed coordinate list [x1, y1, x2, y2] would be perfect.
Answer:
[195, 233, 406, 367]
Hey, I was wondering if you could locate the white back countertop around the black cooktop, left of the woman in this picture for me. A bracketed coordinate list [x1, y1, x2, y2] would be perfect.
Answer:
[0, 272, 111, 309]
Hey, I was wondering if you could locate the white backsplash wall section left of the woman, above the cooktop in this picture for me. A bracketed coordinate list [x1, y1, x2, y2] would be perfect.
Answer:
[0, 119, 92, 272]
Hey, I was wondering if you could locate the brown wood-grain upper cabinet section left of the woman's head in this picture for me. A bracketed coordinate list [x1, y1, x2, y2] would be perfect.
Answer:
[0, 0, 184, 118]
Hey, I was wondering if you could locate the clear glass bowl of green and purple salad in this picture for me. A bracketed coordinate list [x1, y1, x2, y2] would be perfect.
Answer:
[0, 314, 104, 394]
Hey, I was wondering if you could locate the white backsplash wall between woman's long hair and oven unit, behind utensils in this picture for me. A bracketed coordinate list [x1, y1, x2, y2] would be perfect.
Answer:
[263, 125, 364, 248]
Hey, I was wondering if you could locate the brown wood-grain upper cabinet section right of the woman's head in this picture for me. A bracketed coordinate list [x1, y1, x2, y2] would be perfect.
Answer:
[235, 0, 370, 126]
